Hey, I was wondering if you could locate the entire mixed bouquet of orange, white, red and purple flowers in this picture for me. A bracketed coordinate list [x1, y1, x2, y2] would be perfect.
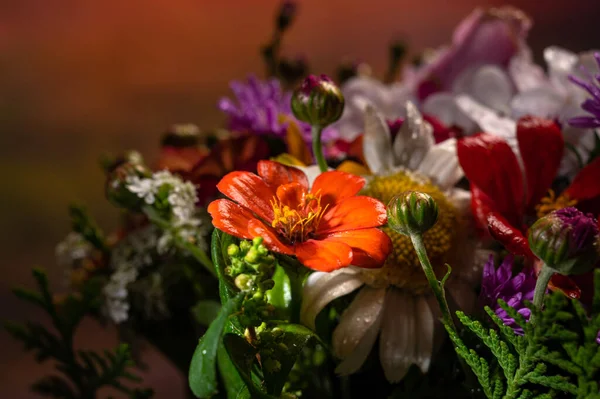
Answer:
[7, 1, 600, 399]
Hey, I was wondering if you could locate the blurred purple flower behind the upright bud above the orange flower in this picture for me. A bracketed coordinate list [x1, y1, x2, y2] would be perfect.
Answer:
[218, 76, 336, 143]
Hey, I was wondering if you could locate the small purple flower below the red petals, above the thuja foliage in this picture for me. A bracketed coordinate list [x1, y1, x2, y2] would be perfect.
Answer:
[479, 255, 537, 335]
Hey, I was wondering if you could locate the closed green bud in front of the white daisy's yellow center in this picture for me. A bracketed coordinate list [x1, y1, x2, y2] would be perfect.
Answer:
[387, 191, 438, 235]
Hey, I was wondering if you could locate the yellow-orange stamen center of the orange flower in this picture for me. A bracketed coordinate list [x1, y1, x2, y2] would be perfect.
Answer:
[271, 193, 328, 244]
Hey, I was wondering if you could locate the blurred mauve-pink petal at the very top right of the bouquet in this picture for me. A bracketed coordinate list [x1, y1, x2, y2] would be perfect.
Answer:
[417, 6, 531, 100]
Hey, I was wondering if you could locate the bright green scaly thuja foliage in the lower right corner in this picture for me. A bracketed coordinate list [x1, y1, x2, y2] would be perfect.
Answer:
[447, 270, 600, 399]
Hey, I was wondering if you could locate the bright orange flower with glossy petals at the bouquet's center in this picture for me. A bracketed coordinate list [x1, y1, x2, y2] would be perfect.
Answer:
[208, 161, 392, 272]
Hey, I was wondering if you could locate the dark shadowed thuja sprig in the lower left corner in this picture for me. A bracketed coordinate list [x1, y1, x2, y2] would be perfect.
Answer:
[5, 270, 152, 399]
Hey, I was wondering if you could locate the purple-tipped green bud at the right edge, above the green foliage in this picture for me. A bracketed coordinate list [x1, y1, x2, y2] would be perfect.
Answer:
[529, 207, 600, 275]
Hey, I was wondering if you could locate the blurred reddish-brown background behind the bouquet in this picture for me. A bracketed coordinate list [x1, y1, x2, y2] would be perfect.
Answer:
[0, 0, 600, 399]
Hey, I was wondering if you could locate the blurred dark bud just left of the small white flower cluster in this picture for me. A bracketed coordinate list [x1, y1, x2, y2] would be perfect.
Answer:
[105, 162, 152, 210]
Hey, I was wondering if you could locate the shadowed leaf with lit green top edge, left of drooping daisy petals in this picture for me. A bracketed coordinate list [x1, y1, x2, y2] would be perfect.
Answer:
[261, 324, 315, 396]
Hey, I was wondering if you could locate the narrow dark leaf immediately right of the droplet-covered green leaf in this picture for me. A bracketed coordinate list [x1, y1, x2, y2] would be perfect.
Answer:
[223, 334, 275, 399]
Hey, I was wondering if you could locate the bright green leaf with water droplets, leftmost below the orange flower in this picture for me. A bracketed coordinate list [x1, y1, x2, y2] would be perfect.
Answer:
[189, 293, 244, 398]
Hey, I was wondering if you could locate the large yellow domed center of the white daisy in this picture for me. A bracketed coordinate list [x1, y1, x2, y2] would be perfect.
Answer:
[361, 171, 462, 294]
